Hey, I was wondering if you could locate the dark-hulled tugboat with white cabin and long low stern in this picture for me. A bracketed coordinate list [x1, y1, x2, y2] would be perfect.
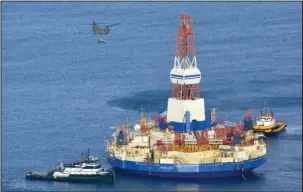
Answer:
[25, 150, 115, 184]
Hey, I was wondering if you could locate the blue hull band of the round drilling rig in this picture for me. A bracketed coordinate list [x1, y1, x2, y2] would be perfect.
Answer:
[108, 156, 267, 179]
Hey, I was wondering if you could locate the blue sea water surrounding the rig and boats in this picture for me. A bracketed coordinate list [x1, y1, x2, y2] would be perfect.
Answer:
[1, 2, 302, 191]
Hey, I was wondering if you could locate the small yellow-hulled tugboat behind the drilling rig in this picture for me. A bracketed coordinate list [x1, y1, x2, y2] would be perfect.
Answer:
[253, 102, 287, 135]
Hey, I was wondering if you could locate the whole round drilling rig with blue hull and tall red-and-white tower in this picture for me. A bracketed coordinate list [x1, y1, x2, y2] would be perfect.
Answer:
[107, 14, 267, 179]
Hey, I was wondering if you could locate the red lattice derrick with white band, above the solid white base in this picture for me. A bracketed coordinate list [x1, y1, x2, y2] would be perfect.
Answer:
[171, 14, 201, 100]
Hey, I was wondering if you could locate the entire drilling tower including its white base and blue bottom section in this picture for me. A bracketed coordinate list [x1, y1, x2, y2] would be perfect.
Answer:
[167, 14, 210, 132]
